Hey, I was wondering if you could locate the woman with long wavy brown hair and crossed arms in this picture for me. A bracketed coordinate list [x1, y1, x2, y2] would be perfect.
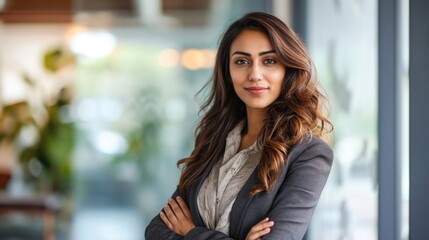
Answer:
[145, 13, 333, 240]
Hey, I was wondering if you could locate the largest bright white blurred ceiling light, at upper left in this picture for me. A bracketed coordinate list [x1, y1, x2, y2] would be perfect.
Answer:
[70, 30, 116, 58]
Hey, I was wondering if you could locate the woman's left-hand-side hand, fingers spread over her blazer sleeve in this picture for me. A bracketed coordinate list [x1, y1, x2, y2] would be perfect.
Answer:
[159, 197, 195, 236]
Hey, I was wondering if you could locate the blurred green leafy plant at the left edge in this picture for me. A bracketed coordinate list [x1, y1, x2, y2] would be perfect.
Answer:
[0, 48, 75, 194]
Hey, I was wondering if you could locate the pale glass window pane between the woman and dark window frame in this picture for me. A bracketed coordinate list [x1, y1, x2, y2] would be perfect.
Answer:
[307, 0, 378, 240]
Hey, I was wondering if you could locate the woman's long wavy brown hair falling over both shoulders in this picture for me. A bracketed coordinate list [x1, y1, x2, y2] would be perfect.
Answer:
[177, 12, 333, 195]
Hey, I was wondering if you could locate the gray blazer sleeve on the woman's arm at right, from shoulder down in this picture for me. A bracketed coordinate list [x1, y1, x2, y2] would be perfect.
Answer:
[263, 136, 333, 240]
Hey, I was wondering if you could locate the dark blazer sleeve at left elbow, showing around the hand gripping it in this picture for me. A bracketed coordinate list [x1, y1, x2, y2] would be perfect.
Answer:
[145, 190, 183, 240]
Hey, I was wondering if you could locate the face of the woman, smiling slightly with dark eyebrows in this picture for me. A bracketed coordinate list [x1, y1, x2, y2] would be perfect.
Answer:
[229, 30, 286, 111]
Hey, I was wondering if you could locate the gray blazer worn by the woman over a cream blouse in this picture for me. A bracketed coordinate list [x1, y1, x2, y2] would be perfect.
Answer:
[145, 136, 333, 240]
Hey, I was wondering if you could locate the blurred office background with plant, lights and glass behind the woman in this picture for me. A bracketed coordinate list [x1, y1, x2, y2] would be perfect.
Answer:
[0, 0, 427, 240]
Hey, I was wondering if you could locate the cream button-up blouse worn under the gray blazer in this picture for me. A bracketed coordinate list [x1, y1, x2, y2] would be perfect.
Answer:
[197, 121, 262, 235]
